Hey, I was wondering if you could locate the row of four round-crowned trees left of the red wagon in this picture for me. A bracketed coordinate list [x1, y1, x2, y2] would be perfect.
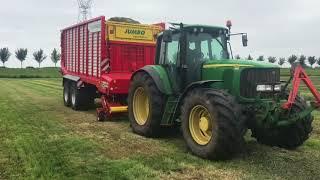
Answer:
[0, 47, 61, 68]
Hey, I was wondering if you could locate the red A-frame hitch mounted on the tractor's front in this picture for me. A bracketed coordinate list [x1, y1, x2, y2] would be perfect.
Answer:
[282, 65, 320, 109]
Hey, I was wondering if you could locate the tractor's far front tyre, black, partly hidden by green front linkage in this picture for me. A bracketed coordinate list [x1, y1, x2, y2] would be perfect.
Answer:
[251, 96, 314, 149]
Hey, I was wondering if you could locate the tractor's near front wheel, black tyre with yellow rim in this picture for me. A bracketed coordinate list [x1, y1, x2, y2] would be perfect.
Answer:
[181, 89, 246, 160]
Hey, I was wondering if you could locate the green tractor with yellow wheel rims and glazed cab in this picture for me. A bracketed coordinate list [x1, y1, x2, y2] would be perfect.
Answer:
[128, 24, 314, 160]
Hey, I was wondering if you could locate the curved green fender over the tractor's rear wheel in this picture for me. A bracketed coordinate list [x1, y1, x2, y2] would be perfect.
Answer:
[131, 65, 172, 95]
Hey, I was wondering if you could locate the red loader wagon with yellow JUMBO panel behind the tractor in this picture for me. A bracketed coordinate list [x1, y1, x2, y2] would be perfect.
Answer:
[61, 16, 164, 120]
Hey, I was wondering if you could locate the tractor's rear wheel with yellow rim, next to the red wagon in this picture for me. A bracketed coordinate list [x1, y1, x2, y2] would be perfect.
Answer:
[128, 73, 165, 137]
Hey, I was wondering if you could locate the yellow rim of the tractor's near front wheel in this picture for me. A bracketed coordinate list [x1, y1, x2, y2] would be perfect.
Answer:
[189, 105, 214, 145]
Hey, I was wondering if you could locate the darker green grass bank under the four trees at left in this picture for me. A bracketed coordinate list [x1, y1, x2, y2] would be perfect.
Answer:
[0, 68, 61, 78]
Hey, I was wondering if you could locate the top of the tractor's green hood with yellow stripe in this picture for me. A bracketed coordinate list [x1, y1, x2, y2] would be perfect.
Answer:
[203, 59, 279, 69]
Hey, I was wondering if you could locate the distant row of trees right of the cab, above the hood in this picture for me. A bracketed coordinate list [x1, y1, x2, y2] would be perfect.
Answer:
[235, 55, 320, 68]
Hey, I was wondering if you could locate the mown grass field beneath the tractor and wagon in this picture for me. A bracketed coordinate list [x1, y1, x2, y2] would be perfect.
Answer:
[0, 78, 320, 179]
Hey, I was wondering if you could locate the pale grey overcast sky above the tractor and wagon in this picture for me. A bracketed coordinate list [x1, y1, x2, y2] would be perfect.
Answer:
[0, 0, 320, 67]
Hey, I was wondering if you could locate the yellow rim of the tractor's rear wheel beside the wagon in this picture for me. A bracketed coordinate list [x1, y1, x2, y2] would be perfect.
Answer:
[133, 87, 149, 126]
